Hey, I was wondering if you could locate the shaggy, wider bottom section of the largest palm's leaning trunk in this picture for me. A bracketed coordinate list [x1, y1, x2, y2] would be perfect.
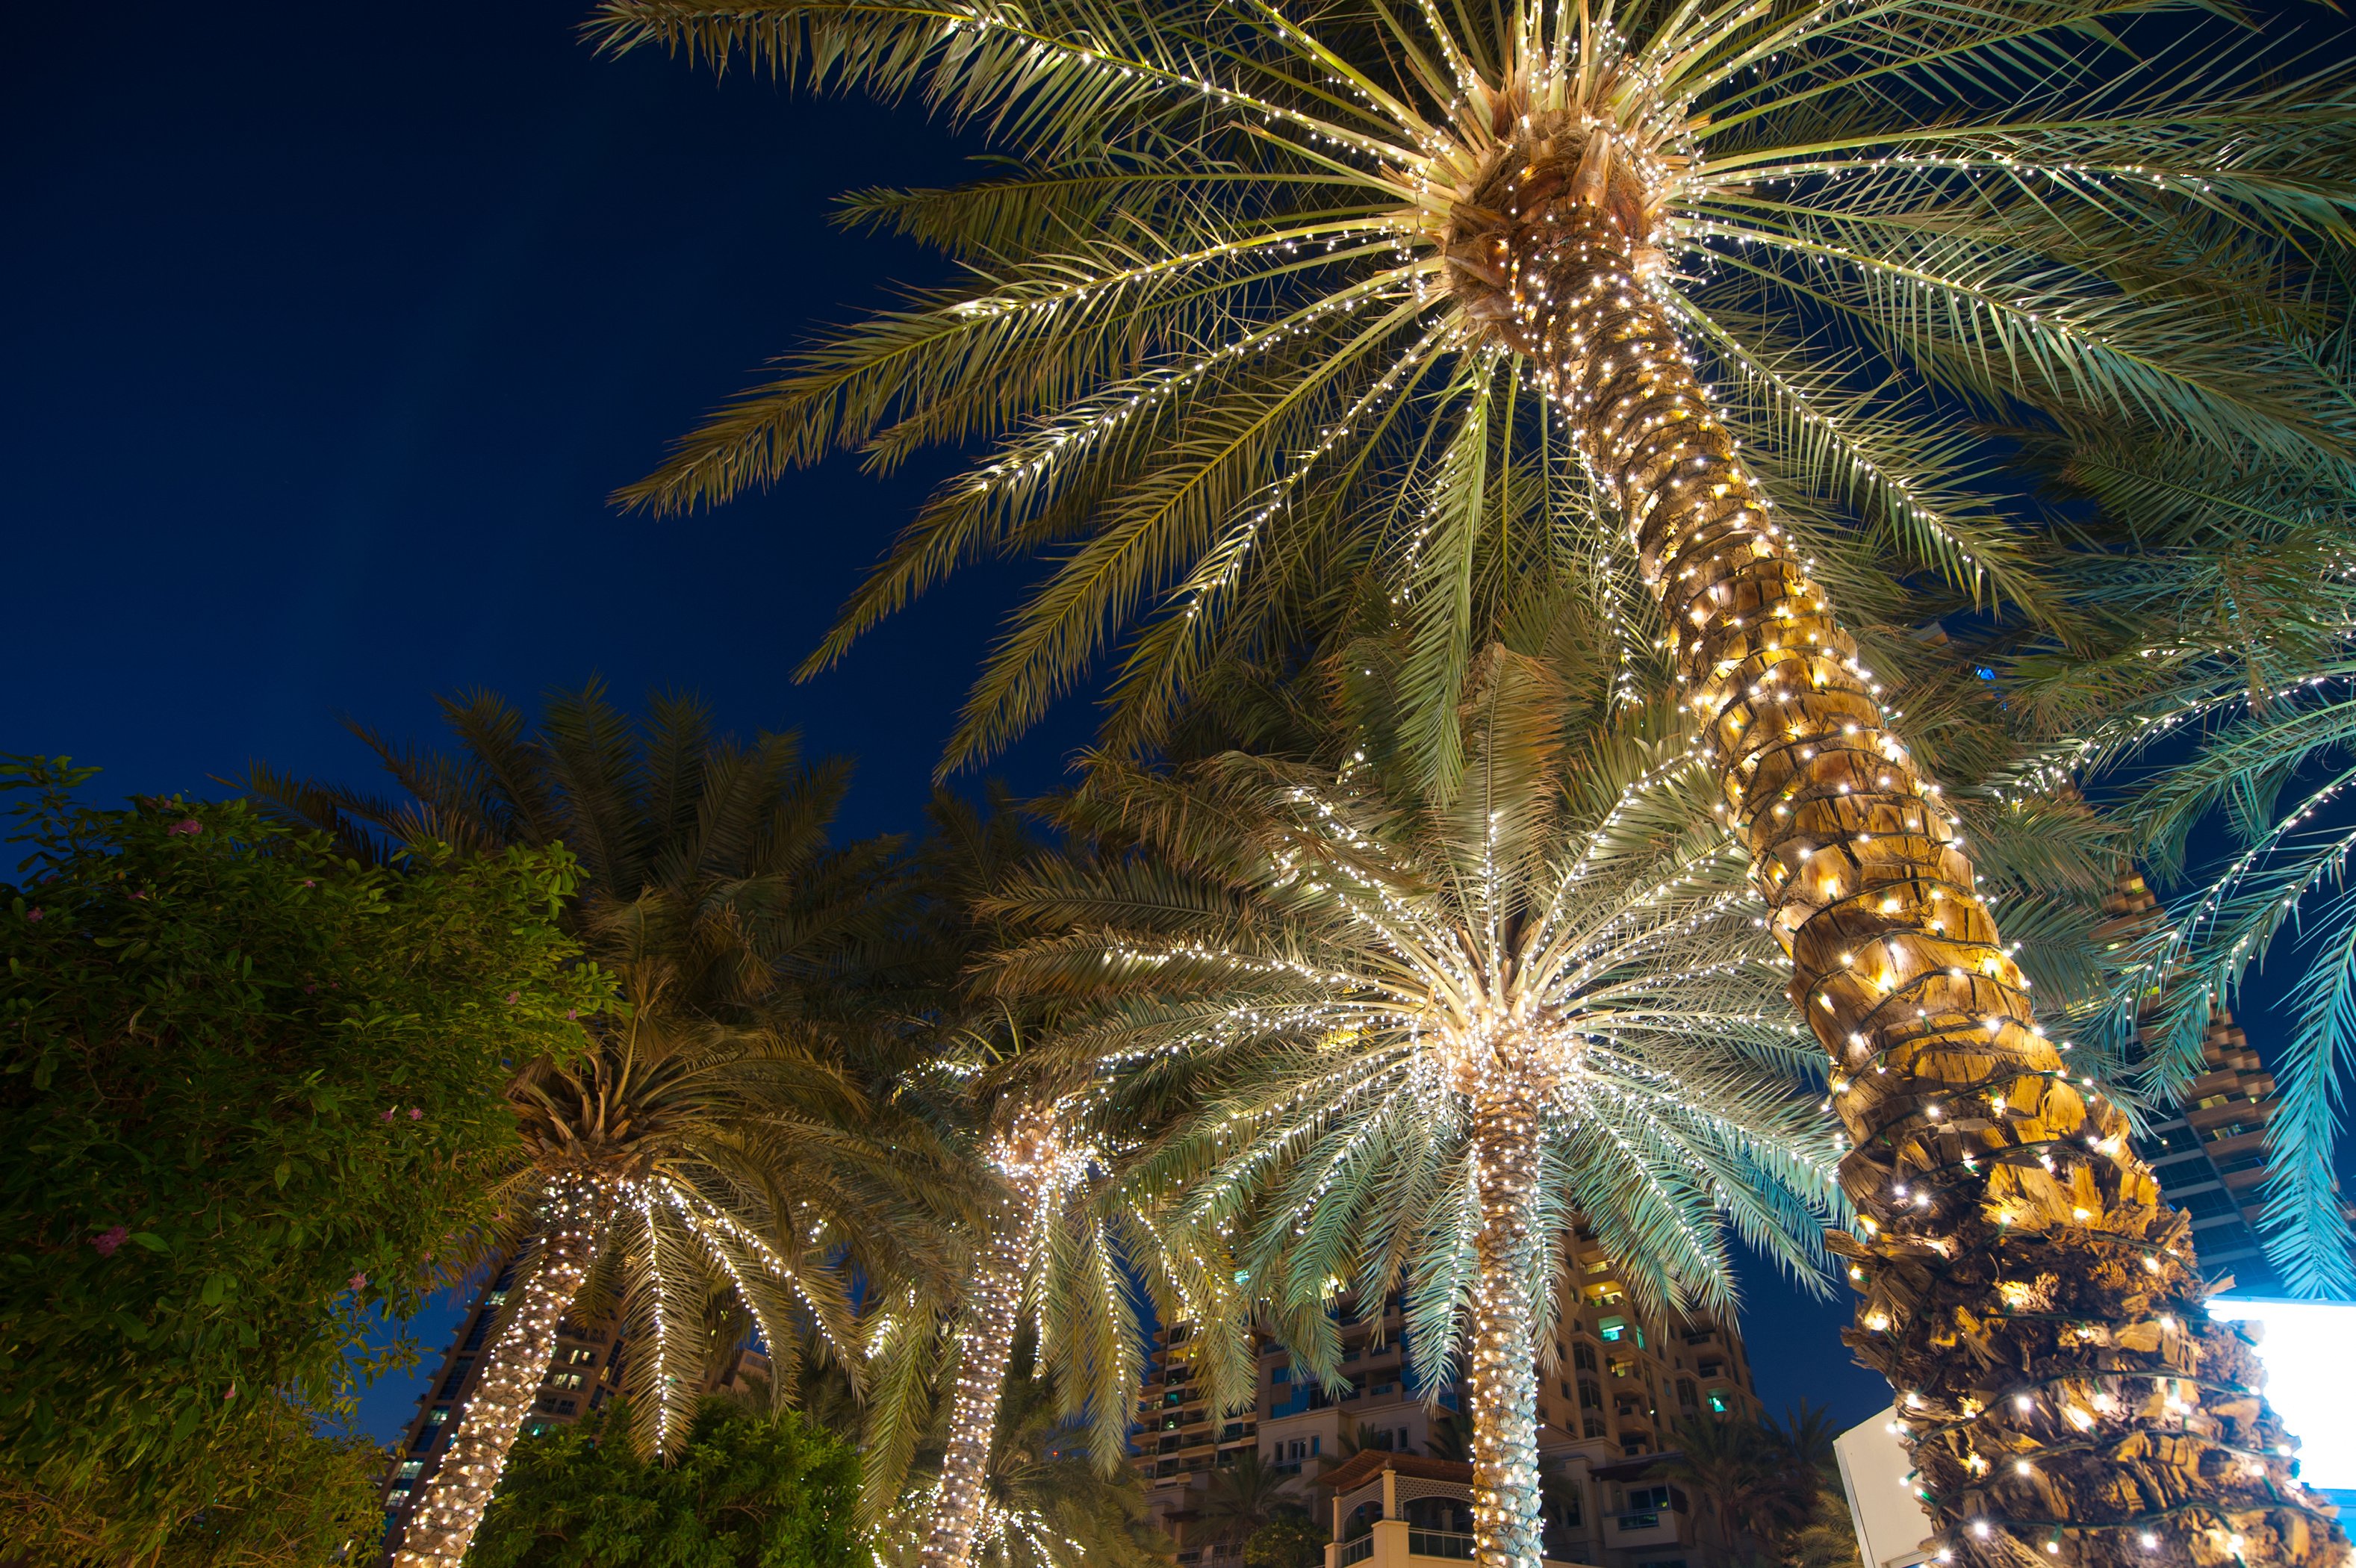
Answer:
[1828, 1172, 2349, 1568]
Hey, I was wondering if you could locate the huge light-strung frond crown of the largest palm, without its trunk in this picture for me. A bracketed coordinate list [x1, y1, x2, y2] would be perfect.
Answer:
[594, 0, 2352, 758]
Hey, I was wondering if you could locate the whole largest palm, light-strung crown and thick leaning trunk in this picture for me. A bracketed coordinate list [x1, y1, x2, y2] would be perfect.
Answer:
[591, 0, 2356, 1564]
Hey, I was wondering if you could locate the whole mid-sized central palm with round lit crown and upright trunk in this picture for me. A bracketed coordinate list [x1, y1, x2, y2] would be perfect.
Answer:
[975, 643, 1833, 1568]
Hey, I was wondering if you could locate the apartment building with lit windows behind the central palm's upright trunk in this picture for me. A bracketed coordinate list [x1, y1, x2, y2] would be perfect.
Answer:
[1134, 1227, 1760, 1568]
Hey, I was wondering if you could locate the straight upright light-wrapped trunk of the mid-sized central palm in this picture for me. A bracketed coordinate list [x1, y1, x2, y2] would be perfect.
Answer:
[1465, 1074, 1541, 1568]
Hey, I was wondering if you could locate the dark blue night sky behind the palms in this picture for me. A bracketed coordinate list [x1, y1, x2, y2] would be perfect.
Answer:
[0, 0, 1887, 1436]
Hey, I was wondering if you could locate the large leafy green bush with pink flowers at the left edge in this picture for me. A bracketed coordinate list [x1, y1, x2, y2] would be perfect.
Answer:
[0, 758, 606, 1544]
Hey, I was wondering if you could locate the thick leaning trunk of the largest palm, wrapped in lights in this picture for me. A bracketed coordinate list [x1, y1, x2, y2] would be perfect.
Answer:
[1503, 199, 2346, 1568]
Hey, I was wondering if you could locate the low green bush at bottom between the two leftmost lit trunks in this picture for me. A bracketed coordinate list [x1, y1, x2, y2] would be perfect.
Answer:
[467, 1396, 867, 1568]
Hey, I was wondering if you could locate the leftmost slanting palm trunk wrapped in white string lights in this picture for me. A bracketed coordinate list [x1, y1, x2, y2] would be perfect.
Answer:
[394, 1180, 615, 1568]
